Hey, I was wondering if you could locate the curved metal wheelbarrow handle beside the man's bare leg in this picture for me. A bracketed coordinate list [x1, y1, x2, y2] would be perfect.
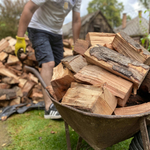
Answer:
[23, 65, 55, 101]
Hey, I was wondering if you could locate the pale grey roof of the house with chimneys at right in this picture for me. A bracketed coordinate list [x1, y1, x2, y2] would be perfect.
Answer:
[114, 17, 149, 37]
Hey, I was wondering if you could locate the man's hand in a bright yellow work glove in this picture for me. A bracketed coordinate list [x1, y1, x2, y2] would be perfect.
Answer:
[15, 36, 26, 57]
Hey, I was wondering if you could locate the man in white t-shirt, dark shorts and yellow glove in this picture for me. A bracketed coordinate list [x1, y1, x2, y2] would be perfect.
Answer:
[15, 0, 81, 119]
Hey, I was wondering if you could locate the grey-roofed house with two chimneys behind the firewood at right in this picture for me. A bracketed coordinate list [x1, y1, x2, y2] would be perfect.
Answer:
[114, 11, 149, 43]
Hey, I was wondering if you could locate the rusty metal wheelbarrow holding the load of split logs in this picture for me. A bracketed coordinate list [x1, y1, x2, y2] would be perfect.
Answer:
[24, 66, 150, 150]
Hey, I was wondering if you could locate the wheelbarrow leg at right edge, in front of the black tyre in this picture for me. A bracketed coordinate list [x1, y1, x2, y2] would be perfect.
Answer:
[140, 117, 150, 150]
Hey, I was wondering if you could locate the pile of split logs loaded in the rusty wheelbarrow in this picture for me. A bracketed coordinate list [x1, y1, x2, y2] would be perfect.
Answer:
[51, 32, 150, 115]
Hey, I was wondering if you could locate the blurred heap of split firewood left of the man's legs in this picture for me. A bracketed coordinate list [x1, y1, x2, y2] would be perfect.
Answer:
[0, 37, 43, 108]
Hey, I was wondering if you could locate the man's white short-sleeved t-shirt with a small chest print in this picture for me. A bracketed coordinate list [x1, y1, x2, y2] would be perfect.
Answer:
[28, 0, 81, 34]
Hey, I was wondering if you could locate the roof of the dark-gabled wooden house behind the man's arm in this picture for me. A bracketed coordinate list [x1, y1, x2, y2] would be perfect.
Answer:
[62, 11, 113, 37]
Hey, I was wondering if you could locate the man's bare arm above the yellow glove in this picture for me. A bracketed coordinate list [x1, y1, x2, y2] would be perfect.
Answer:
[17, 0, 39, 37]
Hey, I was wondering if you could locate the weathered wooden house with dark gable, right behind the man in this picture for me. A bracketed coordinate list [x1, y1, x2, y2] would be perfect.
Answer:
[63, 11, 114, 39]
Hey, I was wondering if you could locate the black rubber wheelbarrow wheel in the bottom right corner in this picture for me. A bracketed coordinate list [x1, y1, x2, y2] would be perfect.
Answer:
[129, 126, 150, 150]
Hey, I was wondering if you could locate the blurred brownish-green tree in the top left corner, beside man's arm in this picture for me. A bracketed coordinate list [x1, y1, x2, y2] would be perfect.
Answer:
[0, 0, 27, 39]
